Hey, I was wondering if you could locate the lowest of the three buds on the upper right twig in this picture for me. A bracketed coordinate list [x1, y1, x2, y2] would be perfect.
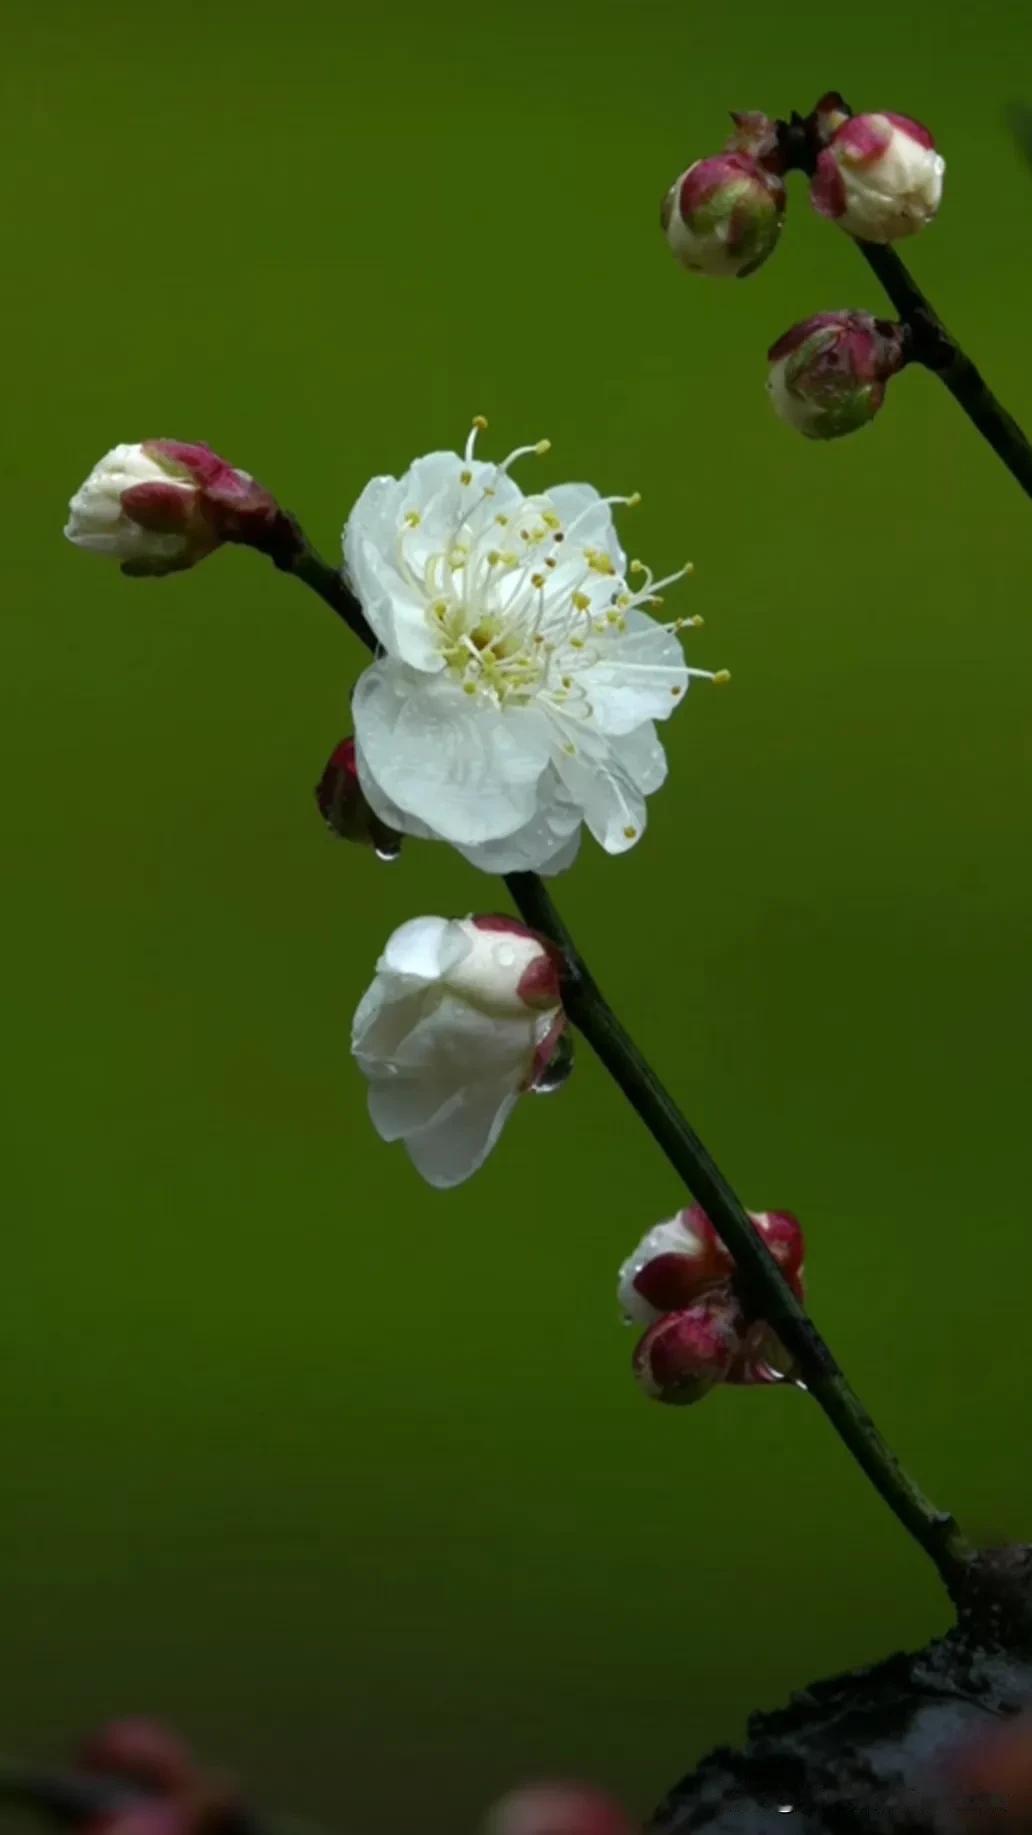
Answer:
[768, 312, 903, 440]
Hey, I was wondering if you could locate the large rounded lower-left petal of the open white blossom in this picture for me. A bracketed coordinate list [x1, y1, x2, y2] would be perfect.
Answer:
[353, 659, 549, 846]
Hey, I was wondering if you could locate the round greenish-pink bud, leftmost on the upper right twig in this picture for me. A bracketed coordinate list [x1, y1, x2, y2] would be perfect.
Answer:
[659, 152, 784, 279]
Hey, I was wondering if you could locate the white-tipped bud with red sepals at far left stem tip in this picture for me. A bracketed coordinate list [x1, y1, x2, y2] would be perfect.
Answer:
[64, 440, 297, 576]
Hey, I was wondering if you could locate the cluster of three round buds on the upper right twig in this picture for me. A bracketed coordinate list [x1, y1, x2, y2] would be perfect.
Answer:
[661, 92, 946, 440]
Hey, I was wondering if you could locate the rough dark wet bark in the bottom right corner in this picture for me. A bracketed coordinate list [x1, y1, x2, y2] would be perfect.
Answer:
[650, 1549, 1032, 1835]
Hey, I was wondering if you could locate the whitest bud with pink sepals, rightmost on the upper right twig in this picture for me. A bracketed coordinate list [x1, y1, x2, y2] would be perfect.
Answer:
[810, 110, 946, 242]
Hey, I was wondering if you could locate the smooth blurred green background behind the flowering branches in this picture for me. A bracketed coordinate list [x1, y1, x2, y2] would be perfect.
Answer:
[0, 0, 1032, 1835]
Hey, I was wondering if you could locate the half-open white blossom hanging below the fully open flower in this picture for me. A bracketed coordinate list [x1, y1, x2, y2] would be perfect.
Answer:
[351, 918, 566, 1187]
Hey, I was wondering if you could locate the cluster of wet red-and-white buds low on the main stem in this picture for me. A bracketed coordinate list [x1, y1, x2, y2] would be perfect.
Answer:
[619, 1204, 806, 1404]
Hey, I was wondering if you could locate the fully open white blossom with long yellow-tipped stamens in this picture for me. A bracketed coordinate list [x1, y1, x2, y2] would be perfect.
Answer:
[343, 418, 724, 873]
